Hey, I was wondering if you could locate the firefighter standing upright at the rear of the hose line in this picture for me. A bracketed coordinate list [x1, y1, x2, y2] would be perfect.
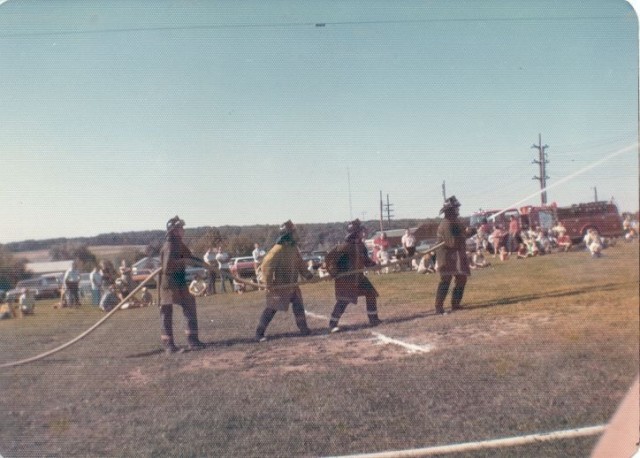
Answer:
[158, 216, 205, 354]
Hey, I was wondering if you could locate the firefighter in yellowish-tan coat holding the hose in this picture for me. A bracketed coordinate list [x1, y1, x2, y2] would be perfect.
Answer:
[256, 221, 313, 342]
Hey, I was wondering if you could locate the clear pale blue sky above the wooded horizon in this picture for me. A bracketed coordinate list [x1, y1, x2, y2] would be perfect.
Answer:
[0, 0, 639, 243]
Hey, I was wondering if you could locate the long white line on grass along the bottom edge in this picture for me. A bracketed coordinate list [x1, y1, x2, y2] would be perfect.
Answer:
[324, 425, 606, 458]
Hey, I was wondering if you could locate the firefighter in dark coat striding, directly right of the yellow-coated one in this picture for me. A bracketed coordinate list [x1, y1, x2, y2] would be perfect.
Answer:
[325, 219, 382, 333]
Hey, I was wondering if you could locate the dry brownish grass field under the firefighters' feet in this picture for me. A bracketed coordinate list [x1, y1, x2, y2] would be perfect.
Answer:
[0, 244, 639, 457]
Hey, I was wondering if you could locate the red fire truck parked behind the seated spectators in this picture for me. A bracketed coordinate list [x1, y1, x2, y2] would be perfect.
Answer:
[470, 202, 623, 243]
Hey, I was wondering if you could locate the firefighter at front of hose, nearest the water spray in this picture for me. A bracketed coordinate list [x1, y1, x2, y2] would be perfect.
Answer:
[436, 196, 471, 315]
